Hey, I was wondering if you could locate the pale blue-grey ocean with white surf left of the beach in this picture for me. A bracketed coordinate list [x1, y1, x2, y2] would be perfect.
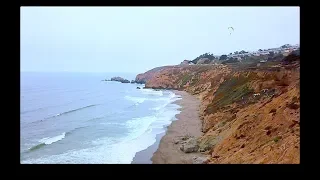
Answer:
[20, 72, 181, 164]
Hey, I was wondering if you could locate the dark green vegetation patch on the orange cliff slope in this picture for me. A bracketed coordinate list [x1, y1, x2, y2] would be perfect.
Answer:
[206, 75, 253, 114]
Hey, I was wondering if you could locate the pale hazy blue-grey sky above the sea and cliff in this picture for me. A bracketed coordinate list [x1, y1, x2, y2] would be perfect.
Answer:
[20, 7, 300, 73]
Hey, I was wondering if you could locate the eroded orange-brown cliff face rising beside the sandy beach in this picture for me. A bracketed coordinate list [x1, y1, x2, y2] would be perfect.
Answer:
[139, 62, 300, 164]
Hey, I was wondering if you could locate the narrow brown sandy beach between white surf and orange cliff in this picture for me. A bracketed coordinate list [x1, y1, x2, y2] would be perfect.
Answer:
[131, 90, 204, 164]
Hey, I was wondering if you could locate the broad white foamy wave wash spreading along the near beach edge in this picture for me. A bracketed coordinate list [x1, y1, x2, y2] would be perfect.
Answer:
[21, 107, 182, 164]
